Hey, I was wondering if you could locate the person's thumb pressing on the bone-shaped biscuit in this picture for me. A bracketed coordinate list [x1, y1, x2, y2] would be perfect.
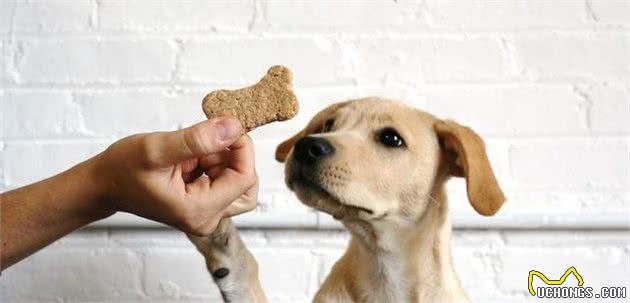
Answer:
[149, 117, 243, 166]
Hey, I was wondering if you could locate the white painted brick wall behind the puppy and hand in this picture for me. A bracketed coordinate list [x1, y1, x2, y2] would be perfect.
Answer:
[0, 0, 630, 302]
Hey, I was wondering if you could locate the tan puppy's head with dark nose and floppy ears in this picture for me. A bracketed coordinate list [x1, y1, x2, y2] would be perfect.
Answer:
[276, 98, 504, 228]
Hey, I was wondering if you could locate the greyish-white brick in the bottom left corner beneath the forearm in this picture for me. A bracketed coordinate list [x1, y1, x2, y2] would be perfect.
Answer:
[0, 248, 142, 302]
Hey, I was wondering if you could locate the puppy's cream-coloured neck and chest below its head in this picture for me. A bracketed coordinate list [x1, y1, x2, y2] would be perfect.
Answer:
[345, 187, 467, 302]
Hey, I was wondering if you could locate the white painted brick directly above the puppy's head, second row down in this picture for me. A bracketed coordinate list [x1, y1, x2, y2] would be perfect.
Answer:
[346, 38, 509, 85]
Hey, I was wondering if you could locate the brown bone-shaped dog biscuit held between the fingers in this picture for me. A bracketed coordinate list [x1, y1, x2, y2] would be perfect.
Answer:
[202, 65, 299, 132]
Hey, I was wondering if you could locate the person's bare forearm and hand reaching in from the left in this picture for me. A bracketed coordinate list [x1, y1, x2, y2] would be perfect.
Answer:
[0, 118, 258, 269]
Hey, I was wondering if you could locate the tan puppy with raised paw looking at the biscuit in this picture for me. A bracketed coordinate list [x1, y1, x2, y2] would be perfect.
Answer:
[190, 98, 505, 302]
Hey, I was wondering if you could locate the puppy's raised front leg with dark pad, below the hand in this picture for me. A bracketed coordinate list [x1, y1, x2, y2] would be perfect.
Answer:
[188, 218, 267, 303]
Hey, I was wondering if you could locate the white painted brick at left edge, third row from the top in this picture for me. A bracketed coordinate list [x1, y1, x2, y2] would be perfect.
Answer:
[2, 91, 83, 138]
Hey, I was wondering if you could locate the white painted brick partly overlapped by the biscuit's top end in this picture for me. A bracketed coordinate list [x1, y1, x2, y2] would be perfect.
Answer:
[178, 38, 344, 85]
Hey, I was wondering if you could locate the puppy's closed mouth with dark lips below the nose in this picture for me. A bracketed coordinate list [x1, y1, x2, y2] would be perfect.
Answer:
[291, 177, 374, 220]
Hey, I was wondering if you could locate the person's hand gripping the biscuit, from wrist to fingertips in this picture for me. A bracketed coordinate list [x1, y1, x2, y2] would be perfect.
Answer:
[93, 118, 258, 236]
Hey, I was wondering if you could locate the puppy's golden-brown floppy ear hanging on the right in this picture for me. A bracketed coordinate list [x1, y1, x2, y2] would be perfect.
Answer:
[434, 120, 505, 216]
